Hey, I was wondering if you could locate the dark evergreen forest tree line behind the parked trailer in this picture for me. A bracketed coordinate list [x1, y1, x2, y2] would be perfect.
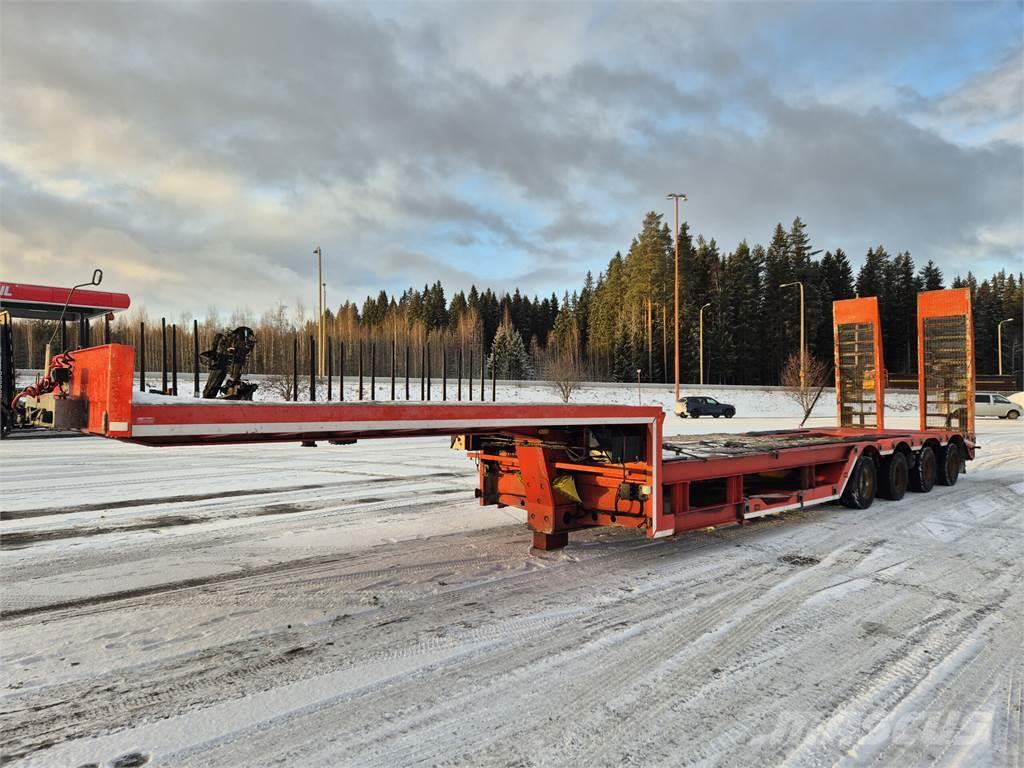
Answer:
[9, 212, 1024, 385]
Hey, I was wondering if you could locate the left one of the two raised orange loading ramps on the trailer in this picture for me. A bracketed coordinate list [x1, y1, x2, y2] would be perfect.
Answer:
[833, 296, 886, 429]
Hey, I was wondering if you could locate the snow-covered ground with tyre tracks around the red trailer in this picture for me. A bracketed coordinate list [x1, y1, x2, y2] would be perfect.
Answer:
[0, 393, 1024, 768]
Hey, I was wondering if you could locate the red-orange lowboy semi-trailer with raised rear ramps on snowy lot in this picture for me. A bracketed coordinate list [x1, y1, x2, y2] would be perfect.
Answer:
[29, 290, 975, 549]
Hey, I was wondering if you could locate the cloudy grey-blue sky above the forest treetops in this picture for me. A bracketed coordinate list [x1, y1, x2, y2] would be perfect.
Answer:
[0, 0, 1024, 314]
